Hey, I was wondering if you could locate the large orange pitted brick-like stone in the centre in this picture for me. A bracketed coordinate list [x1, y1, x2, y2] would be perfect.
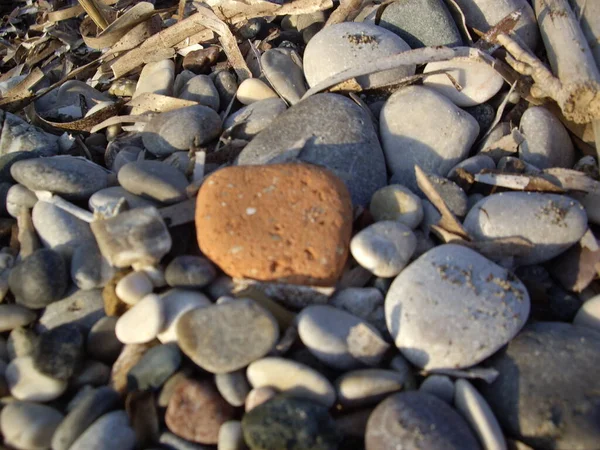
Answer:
[196, 163, 352, 286]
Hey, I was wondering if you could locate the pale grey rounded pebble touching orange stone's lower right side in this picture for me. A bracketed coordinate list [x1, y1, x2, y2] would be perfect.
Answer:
[350, 220, 417, 278]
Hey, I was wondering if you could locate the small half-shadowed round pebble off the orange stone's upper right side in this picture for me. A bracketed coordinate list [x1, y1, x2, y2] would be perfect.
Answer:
[369, 184, 422, 230]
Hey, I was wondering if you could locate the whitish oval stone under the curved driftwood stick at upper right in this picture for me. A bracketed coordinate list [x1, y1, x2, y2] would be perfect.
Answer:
[423, 58, 504, 107]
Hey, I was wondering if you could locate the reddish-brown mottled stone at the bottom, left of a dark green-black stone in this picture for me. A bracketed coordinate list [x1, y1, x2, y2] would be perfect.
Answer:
[165, 379, 235, 444]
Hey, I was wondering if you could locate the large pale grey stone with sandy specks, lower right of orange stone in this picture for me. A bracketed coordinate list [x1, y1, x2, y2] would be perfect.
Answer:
[385, 244, 530, 370]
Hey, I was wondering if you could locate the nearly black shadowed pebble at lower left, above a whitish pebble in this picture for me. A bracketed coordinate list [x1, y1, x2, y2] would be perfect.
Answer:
[31, 323, 85, 381]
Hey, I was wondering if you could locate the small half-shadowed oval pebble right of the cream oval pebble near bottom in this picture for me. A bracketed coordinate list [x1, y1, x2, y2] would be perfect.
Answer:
[335, 369, 405, 408]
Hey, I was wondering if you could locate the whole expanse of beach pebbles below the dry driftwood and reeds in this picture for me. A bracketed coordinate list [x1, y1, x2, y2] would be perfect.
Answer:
[0, 0, 600, 450]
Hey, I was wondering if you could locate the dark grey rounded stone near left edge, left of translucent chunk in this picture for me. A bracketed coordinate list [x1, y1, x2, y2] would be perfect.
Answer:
[8, 249, 69, 309]
